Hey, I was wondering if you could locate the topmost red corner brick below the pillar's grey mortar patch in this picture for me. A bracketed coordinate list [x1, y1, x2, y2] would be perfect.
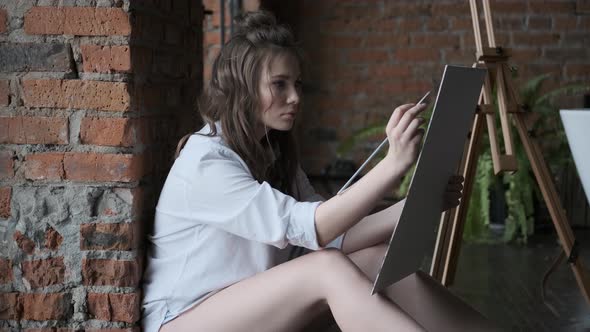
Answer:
[80, 223, 134, 250]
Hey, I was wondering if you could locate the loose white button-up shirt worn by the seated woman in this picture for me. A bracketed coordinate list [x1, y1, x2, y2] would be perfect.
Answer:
[142, 123, 342, 332]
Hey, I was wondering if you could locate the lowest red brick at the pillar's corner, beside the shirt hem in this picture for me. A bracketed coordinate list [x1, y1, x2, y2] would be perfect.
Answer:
[88, 293, 140, 323]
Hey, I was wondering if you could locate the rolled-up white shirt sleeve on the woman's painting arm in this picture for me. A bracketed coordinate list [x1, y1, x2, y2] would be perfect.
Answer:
[185, 149, 321, 250]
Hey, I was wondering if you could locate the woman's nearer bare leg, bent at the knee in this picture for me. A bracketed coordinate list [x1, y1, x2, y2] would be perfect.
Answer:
[160, 249, 423, 332]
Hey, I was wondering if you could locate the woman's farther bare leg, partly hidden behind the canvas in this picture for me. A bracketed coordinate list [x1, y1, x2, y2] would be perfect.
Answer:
[348, 244, 499, 331]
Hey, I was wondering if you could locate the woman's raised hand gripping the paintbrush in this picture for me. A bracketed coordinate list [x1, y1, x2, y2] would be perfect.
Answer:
[385, 104, 426, 174]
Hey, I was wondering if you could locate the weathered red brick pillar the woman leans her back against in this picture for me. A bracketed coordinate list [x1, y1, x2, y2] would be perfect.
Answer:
[0, 0, 203, 331]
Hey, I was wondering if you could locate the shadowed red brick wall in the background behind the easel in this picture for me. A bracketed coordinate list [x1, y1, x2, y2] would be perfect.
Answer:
[293, 0, 590, 174]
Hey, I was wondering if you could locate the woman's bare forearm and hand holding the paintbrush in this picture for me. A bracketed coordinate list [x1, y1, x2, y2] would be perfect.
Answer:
[315, 104, 425, 246]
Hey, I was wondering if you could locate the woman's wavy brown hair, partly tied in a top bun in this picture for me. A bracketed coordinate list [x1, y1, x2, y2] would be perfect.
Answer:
[177, 11, 302, 195]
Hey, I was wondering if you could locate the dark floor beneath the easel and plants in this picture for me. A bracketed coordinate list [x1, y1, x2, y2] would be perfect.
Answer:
[451, 229, 590, 331]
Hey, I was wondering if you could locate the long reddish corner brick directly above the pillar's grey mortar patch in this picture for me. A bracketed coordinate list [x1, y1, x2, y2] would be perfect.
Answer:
[64, 152, 144, 182]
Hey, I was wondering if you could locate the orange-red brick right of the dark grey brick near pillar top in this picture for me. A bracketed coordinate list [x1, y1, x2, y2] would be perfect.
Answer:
[80, 45, 131, 73]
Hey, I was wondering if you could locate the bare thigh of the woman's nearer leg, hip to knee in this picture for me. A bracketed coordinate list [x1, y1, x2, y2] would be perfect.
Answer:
[160, 250, 338, 332]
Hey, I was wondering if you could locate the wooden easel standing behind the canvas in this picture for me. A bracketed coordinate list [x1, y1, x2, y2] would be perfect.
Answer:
[430, 0, 590, 304]
